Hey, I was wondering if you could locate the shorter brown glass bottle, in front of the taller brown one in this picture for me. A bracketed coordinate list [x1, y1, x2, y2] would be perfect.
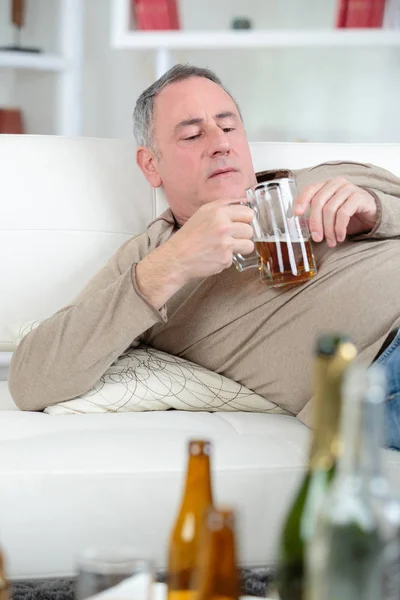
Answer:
[194, 507, 240, 600]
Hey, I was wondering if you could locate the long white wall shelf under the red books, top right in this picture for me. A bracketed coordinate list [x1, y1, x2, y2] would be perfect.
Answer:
[113, 29, 400, 50]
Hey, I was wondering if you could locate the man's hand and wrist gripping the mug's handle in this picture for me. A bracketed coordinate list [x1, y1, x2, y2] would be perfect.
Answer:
[136, 198, 254, 309]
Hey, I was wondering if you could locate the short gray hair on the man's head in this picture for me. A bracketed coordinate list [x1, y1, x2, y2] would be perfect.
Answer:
[133, 64, 242, 150]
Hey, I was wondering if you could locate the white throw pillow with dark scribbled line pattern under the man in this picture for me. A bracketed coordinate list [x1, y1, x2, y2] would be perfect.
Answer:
[1, 321, 288, 415]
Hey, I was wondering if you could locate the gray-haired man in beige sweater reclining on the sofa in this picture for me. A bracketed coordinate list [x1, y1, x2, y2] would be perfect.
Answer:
[9, 65, 400, 441]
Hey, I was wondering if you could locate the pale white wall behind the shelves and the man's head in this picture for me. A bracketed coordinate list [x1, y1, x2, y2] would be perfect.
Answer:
[0, 0, 400, 142]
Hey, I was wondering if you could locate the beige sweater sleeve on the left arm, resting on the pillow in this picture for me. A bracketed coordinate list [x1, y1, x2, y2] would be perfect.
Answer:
[9, 236, 166, 410]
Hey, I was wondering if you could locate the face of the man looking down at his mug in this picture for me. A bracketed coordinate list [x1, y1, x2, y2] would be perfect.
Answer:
[144, 77, 255, 223]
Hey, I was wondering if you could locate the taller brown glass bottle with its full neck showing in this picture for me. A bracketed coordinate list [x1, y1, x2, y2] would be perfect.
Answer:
[167, 440, 212, 600]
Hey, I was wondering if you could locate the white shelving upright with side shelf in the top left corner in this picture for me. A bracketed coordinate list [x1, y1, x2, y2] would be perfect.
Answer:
[0, 0, 84, 136]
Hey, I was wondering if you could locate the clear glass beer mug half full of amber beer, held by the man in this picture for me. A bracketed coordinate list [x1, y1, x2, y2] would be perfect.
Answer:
[233, 177, 317, 287]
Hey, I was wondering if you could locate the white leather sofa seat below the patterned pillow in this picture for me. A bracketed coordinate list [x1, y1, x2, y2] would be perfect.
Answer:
[0, 410, 309, 578]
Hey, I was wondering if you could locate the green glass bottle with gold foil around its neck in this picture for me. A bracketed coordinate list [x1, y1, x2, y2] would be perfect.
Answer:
[276, 335, 357, 600]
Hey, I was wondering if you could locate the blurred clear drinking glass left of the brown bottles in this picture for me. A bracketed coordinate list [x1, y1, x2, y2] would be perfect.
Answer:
[75, 548, 155, 600]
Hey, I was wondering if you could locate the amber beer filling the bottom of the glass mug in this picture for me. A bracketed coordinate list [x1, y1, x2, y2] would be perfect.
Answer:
[254, 237, 317, 287]
